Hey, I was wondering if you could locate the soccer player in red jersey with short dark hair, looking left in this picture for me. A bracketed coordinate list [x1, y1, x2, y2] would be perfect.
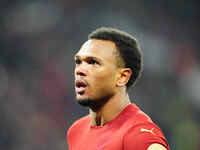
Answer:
[67, 28, 170, 150]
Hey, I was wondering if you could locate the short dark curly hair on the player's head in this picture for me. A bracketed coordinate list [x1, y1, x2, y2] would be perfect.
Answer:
[88, 27, 143, 89]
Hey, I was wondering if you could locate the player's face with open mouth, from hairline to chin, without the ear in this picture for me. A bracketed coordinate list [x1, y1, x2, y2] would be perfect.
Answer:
[74, 39, 118, 105]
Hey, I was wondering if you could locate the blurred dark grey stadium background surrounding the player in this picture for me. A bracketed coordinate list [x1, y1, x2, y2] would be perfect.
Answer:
[0, 0, 200, 150]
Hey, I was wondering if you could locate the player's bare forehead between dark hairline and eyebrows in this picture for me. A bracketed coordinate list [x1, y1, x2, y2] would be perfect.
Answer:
[76, 39, 117, 60]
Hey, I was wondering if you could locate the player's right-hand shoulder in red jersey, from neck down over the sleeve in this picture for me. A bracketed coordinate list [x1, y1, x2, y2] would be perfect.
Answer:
[123, 104, 169, 150]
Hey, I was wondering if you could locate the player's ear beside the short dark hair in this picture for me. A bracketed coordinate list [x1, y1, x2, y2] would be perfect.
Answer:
[117, 68, 132, 87]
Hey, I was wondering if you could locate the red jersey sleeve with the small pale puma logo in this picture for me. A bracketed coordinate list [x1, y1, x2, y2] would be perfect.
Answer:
[123, 124, 170, 150]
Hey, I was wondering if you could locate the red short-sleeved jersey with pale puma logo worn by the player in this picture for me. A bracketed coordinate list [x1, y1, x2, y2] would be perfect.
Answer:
[67, 104, 170, 150]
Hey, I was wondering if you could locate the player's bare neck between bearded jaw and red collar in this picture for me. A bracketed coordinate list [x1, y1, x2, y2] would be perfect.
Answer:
[90, 90, 130, 126]
